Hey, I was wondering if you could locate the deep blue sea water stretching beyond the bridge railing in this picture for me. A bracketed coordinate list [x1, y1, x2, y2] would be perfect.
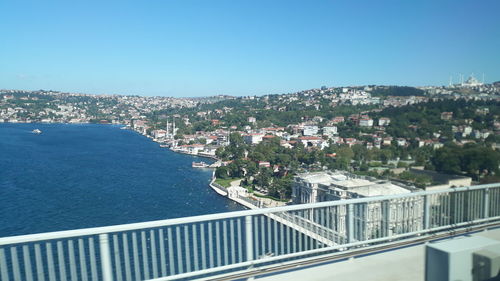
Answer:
[0, 123, 242, 237]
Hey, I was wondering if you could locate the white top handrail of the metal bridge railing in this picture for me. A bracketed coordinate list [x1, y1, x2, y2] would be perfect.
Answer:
[0, 183, 500, 246]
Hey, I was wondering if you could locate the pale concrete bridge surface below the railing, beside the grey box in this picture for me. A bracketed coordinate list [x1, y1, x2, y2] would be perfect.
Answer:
[256, 228, 500, 281]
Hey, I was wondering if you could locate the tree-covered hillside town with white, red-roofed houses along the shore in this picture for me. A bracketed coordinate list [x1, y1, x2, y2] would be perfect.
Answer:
[0, 76, 500, 202]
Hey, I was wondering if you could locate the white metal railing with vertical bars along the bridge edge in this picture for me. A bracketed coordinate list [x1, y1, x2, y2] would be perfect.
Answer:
[0, 184, 500, 281]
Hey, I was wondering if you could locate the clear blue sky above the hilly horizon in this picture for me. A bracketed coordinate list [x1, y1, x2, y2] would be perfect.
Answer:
[0, 0, 500, 97]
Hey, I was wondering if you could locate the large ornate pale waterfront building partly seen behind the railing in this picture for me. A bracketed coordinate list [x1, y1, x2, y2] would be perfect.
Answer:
[292, 171, 423, 240]
